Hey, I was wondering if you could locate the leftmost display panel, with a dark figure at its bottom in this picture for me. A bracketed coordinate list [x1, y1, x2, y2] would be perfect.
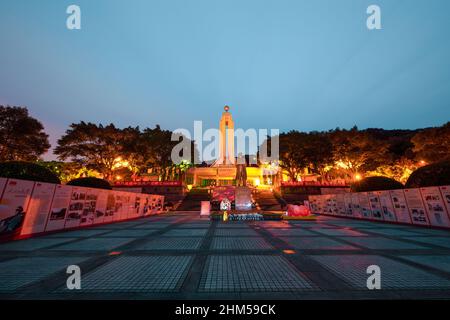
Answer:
[0, 179, 34, 235]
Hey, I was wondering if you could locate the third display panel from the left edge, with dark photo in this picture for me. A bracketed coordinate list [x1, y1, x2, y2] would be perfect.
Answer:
[45, 185, 73, 231]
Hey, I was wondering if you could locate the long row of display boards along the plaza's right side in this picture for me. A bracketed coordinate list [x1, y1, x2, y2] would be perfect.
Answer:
[309, 186, 450, 228]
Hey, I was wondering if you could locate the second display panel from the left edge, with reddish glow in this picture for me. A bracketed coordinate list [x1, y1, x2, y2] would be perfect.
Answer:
[20, 182, 56, 236]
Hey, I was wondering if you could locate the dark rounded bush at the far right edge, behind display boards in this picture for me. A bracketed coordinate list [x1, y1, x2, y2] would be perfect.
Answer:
[406, 161, 450, 188]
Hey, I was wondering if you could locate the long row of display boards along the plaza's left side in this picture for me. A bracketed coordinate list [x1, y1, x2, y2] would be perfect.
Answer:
[0, 177, 164, 237]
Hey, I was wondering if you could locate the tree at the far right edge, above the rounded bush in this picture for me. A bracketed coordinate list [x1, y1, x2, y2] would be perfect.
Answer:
[412, 122, 450, 163]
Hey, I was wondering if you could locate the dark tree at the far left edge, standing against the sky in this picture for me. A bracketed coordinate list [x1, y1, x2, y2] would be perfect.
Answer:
[0, 106, 50, 161]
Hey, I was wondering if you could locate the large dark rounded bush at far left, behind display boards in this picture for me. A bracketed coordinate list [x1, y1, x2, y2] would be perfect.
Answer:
[0, 161, 61, 184]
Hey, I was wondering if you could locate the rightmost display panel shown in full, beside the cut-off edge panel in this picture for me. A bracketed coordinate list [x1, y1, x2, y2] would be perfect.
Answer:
[420, 187, 450, 227]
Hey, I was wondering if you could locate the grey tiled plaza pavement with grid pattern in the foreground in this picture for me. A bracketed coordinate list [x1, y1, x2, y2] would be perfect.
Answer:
[0, 213, 450, 299]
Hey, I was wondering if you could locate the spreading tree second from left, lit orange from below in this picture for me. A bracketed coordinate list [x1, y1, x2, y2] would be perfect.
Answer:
[55, 121, 131, 179]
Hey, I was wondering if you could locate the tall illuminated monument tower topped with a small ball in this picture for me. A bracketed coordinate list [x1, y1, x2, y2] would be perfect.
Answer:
[213, 106, 236, 167]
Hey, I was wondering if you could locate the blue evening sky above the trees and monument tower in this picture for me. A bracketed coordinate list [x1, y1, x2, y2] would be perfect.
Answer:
[0, 0, 450, 160]
